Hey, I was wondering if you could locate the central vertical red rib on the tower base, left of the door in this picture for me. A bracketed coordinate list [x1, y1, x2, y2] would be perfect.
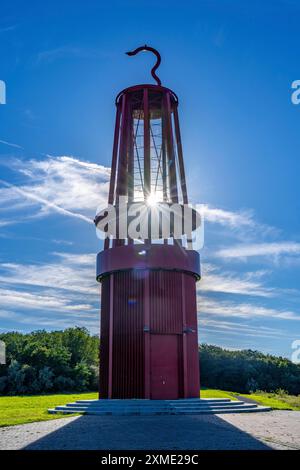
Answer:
[144, 271, 151, 398]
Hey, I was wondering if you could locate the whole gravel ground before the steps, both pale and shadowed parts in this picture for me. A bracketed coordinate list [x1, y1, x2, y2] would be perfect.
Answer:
[0, 411, 300, 450]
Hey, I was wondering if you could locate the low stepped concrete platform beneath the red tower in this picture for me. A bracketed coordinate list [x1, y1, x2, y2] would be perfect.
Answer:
[48, 398, 271, 416]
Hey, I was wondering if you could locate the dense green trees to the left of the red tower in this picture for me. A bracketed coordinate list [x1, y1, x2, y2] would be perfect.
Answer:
[0, 328, 99, 395]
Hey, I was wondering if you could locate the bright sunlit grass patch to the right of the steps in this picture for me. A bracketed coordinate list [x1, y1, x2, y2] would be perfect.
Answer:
[241, 392, 300, 411]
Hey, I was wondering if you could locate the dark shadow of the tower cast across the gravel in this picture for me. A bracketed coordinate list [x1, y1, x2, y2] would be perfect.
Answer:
[24, 415, 270, 450]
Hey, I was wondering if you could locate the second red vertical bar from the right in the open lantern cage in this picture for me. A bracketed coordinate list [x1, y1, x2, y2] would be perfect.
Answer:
[165, 91, 178, 202]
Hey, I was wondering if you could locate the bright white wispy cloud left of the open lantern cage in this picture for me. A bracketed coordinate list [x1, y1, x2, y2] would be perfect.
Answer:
[0, 156, 110, 223]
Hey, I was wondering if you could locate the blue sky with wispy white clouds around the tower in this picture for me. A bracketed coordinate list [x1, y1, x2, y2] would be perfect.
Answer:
[0, 0, 300, 357]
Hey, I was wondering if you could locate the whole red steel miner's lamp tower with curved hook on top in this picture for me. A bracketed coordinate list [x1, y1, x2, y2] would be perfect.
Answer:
[95, 46, 200, 399]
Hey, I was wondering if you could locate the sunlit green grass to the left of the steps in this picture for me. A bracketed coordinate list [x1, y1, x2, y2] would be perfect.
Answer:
[0, 393, 97, 427]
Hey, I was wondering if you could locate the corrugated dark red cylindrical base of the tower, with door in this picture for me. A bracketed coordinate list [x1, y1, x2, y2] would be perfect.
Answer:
[99, 270, 200, 399]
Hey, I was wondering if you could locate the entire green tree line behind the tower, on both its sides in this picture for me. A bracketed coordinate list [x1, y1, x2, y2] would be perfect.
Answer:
[0, 327, 300, 395]
